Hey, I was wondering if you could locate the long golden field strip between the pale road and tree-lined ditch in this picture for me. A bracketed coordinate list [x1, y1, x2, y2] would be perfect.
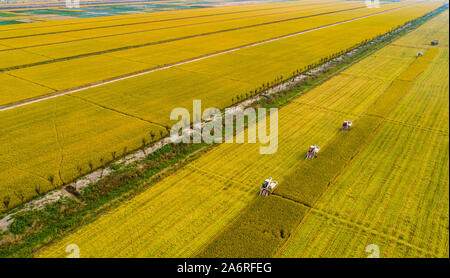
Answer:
[0, 0, 442, 210]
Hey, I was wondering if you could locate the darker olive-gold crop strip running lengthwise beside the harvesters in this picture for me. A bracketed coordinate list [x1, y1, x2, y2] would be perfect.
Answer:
[199, 37, 442, 257]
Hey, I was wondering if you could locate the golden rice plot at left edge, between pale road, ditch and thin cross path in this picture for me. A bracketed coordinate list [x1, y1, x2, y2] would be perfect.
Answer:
[0, 96, 167, 210]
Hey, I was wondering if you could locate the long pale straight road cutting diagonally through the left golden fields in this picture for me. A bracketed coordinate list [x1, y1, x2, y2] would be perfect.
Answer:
[0, 2, 422, 112]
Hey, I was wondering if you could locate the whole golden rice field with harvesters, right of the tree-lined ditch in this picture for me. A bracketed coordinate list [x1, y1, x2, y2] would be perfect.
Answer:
[36, 7, 449, 257]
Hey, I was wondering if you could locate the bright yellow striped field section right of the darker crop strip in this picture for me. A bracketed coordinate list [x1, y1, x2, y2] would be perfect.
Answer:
[278, 13, 449, 257]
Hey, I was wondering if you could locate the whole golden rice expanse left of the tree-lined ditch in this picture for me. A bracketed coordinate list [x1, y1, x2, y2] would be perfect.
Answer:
[0, 1, 439, 211]
